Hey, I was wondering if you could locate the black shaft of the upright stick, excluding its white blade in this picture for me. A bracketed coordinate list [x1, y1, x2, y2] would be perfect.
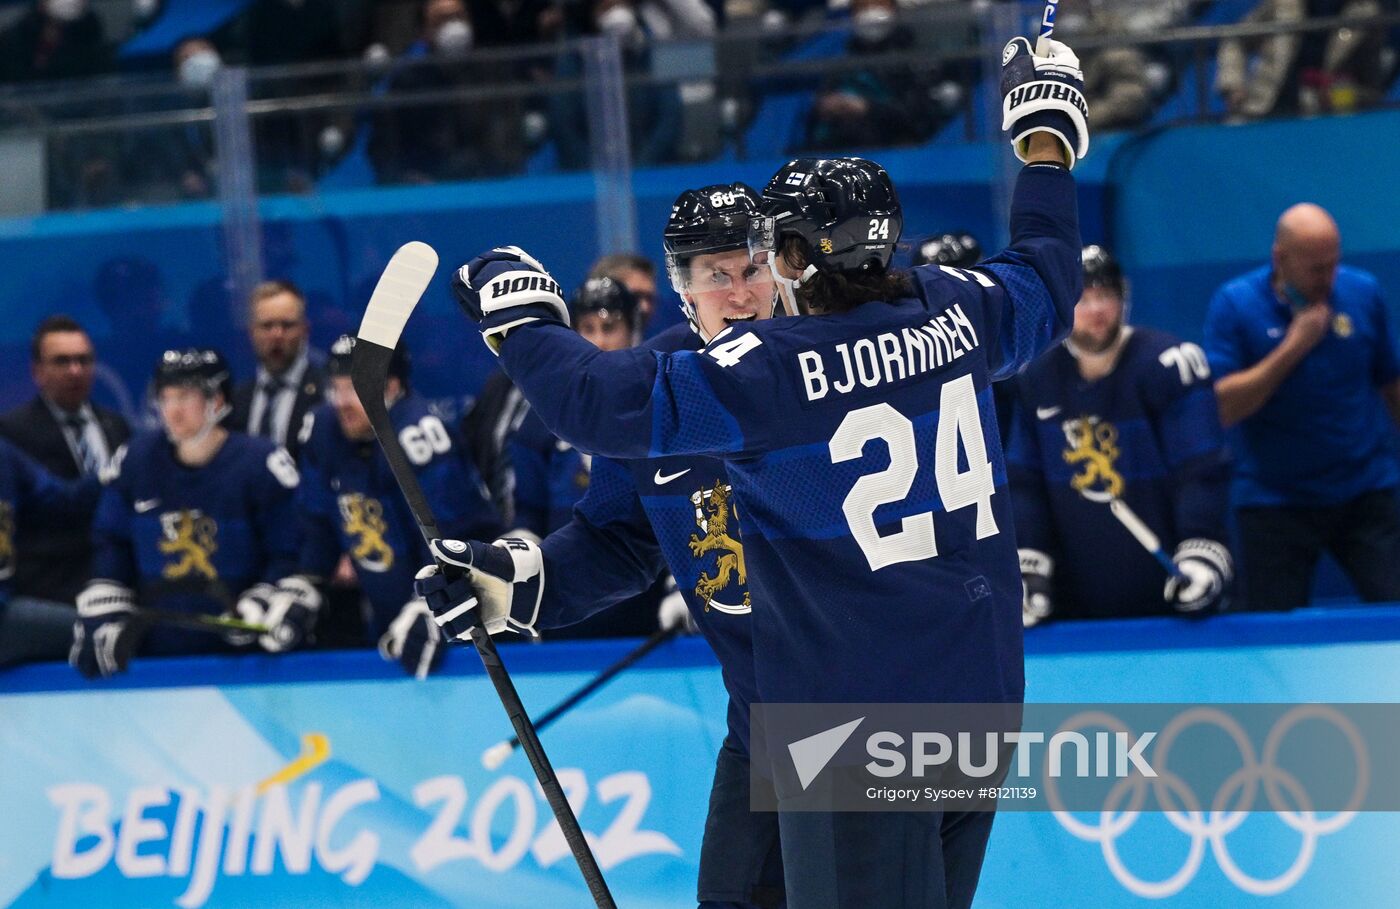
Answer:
[350, 333, 617, 909]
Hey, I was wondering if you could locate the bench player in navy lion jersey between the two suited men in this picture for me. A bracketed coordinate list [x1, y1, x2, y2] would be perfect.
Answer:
[70, 347, 321, 678]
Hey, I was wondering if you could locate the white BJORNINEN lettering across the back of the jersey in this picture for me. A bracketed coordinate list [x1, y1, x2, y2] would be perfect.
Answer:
[797, 304, 979, 401]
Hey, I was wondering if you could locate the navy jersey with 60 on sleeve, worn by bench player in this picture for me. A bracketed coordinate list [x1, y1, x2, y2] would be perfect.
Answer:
[297, 392, 501, 640]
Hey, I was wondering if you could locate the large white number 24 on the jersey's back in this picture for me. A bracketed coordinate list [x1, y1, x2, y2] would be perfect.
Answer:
[830, 375, 1001, 571]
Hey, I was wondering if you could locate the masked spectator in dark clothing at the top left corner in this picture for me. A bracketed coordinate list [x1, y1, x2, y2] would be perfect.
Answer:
[0, 0, 112, 83]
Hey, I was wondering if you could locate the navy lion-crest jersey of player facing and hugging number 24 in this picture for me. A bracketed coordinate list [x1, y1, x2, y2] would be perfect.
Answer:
[526, 325, 755, 749]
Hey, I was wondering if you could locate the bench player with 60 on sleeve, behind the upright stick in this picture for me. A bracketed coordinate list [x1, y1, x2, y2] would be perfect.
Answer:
[297, 335, 500, 678]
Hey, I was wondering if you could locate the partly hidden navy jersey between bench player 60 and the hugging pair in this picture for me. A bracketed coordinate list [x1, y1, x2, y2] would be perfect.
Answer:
[505, 413, 591, 538]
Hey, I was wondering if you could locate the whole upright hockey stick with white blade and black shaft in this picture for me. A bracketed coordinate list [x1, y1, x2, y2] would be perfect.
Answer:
[350, 241, 616, 909]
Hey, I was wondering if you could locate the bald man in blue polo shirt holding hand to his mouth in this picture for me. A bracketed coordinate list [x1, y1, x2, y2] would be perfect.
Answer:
[1205, 203, 1400, 609]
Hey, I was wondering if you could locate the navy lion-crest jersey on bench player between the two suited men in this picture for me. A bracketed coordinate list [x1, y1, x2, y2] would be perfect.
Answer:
[92, 430, 300, 654]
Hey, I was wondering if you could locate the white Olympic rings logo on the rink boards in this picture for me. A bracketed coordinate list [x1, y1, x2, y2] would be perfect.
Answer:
[1044, 705, 1371, 899]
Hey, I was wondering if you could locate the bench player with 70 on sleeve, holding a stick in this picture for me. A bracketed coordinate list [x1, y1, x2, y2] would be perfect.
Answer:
[1007, 247, 1232, 627]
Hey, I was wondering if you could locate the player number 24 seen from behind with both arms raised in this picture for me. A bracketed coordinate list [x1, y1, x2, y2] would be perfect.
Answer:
[433, 38, 1088, 909]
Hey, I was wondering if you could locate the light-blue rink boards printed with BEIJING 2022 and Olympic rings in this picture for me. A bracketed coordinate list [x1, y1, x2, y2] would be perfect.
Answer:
[0, 606, 1400, 909]
